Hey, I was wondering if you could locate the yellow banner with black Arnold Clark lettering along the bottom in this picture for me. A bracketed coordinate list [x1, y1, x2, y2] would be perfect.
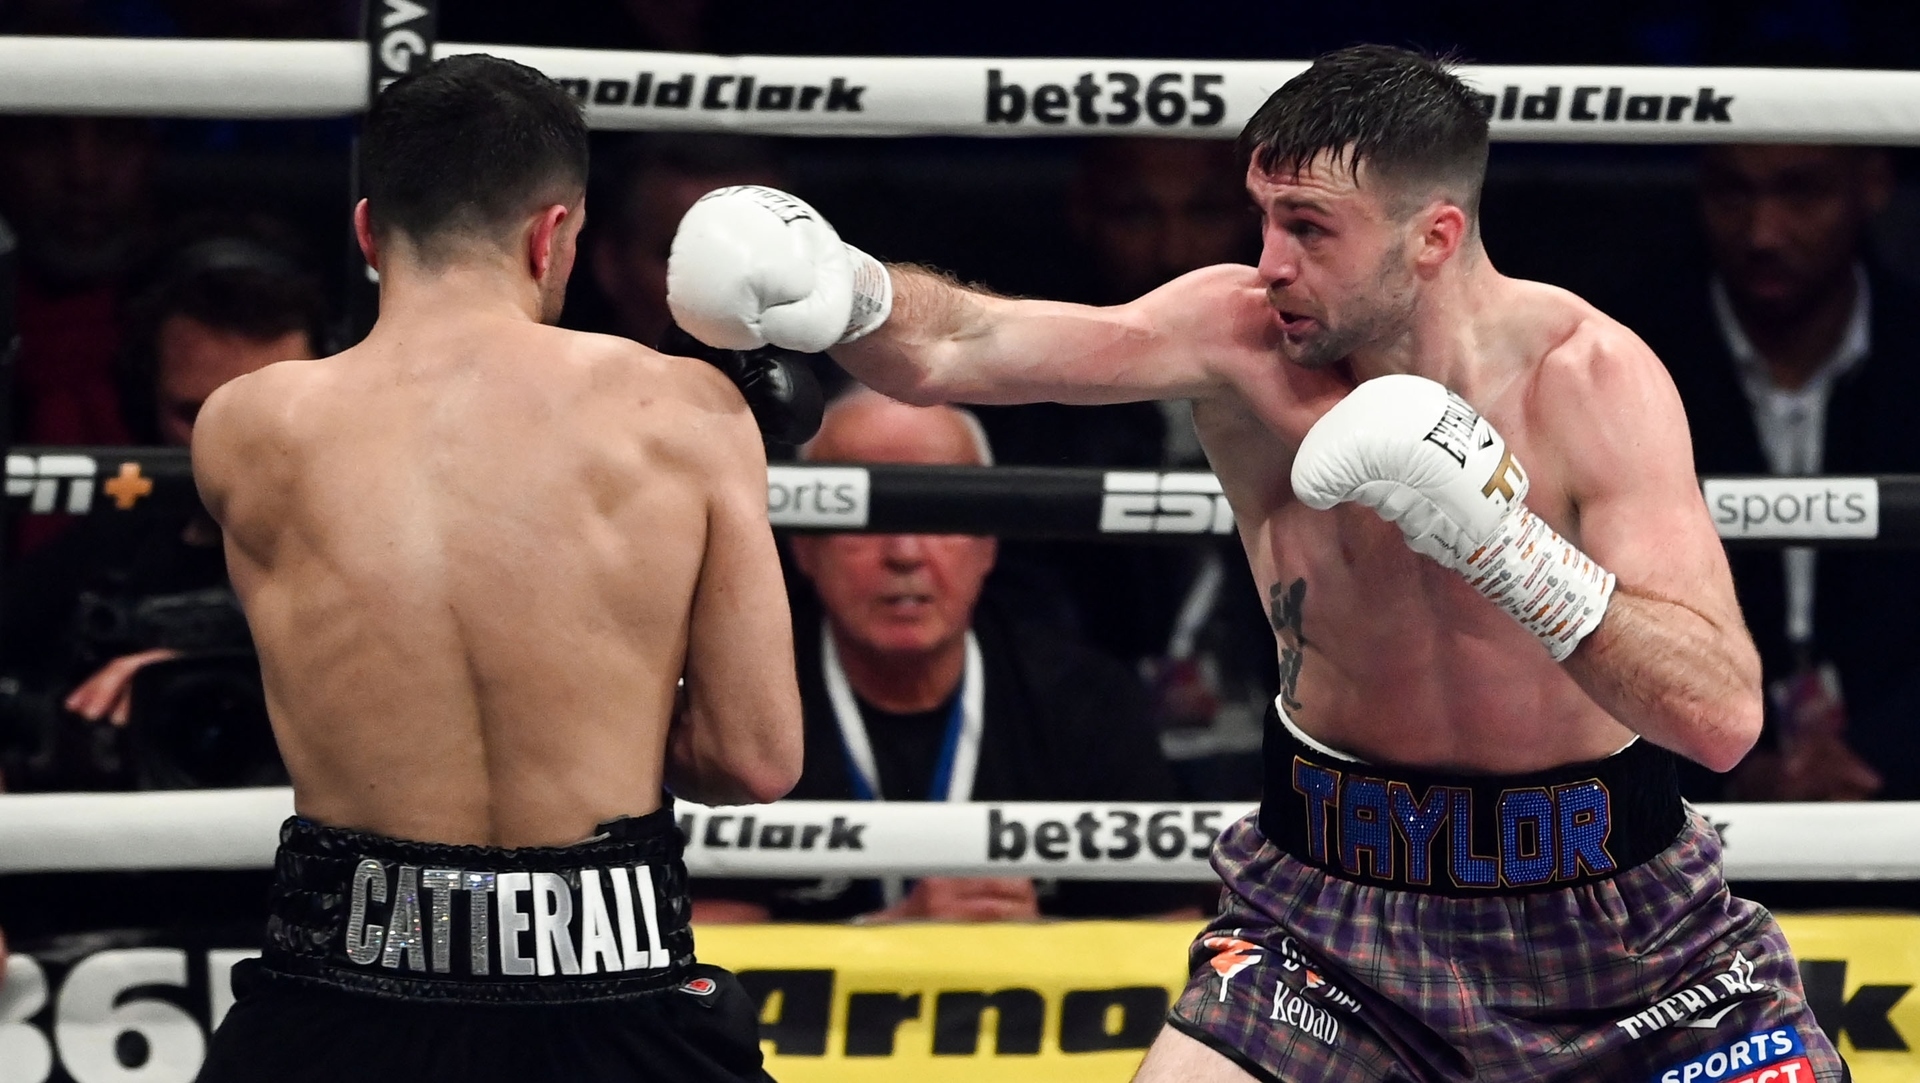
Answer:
[699, 916, 1920, 1083]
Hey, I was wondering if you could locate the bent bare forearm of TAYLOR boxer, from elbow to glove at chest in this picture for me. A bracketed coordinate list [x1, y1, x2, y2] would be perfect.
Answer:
[1565, 586, 1761, 772]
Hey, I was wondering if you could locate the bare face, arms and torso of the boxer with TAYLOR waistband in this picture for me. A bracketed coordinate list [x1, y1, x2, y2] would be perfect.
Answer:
[833, 154, 1759, 772]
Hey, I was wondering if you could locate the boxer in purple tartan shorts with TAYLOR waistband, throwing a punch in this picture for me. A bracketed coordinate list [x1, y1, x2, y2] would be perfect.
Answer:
[668, 46, 1845, 1083]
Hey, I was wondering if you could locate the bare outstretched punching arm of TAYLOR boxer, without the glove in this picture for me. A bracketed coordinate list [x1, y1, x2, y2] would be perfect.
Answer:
[831, 265, 1275, 405]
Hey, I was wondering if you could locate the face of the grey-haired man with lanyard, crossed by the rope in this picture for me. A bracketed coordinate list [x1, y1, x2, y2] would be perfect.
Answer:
[793, 396, 995, 659]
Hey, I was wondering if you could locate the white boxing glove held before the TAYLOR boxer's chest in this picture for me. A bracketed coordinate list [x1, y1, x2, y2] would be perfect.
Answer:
[1292, 374, 1615, 661]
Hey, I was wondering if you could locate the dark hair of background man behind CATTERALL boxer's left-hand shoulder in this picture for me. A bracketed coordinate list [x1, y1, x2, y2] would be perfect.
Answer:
[115, 227, 326, 444]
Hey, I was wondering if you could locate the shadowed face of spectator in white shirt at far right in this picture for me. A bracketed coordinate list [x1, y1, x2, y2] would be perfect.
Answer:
[1699, 146, 1887, 319]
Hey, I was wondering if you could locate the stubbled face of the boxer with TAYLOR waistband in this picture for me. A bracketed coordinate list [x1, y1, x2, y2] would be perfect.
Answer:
[1246, 156, 1417, 369]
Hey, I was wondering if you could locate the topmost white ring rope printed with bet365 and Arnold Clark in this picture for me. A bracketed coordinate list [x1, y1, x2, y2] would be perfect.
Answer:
[0, 36, 1920, 144]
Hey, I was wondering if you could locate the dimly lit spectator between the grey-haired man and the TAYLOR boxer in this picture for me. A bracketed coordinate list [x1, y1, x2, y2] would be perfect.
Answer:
[981, 138, 1277, 801]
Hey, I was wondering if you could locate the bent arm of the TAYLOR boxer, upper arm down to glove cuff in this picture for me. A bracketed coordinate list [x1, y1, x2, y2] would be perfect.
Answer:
[1538, 336, 1761, 770]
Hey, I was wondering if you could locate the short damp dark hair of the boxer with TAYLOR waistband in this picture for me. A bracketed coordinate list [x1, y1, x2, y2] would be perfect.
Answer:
[1240, 44, 1486, 217]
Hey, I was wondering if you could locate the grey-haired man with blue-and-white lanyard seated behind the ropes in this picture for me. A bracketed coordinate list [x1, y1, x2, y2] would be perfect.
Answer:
[695, 388, 1194, 922]
